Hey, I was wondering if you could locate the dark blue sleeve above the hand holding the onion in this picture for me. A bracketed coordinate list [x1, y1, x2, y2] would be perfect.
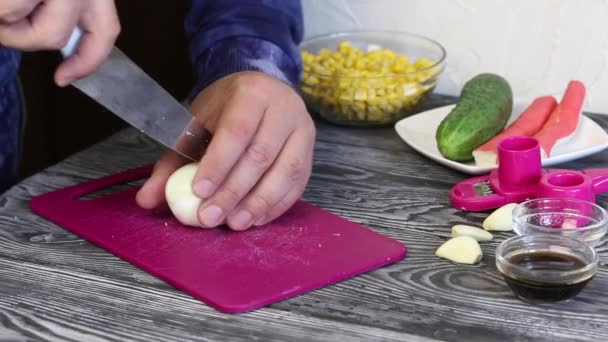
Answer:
[185, 0, 303, 101]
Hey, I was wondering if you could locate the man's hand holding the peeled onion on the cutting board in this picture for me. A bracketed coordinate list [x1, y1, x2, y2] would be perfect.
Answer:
[137, 71, 315, 230]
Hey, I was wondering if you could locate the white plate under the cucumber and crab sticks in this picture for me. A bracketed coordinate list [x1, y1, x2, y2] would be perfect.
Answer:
[395, 103, 608, 175]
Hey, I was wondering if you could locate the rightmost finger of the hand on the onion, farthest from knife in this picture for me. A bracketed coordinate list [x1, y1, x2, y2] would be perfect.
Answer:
[227, 117, 315, 230]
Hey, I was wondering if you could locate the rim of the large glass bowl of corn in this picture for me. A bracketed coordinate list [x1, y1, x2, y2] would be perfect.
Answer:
[298, 30, 447, 80]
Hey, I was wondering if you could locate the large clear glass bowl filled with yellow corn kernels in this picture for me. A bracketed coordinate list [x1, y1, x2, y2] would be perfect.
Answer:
[300, 31, 446, 126]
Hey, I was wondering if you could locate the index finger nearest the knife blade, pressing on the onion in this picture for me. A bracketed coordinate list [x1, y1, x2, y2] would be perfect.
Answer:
[193, 96, 266, 199]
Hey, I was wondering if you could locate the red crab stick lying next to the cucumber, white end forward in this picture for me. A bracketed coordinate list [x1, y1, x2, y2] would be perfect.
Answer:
[473, 96, 557, 167]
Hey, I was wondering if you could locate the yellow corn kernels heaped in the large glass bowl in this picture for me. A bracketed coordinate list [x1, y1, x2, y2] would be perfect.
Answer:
[301, 41, 440, 122]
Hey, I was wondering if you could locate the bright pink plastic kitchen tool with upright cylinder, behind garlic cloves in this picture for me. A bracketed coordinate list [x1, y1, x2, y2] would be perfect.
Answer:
[450, 136, 608, 211]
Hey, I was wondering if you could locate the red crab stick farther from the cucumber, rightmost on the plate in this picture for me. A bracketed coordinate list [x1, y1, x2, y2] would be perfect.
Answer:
[534, 81, 585, 158]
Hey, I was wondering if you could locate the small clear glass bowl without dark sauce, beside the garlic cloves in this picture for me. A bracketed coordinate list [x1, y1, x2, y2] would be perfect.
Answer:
[513, 198, 608, 247]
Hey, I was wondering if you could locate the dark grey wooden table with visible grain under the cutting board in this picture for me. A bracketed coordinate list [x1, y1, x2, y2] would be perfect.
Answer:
[0, 96, 608, 342]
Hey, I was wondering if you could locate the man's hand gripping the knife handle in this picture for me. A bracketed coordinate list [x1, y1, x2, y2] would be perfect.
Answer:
[0, 0, 120, 86]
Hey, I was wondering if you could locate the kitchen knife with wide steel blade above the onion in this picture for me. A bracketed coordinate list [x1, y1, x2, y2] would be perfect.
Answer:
[61, 27, 211, 161]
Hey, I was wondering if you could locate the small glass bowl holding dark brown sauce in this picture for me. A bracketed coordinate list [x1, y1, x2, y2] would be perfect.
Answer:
[496, 235, 598, 304]
